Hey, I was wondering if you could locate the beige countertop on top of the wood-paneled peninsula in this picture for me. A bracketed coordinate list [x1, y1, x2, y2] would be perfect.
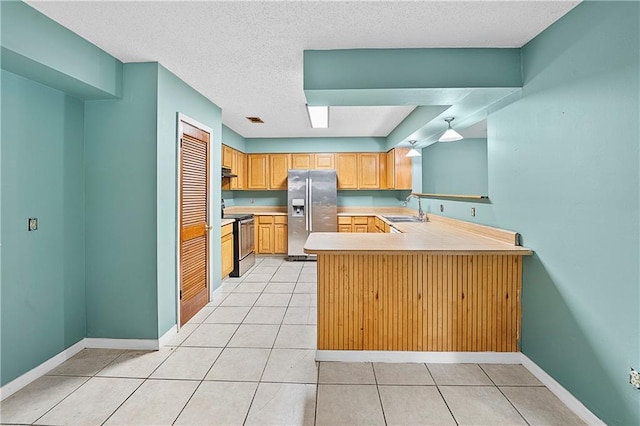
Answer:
[304, 221, 532, 255]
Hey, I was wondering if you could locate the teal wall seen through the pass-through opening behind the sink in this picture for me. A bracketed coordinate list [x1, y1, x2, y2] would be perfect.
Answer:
[422, 139, 489, 195]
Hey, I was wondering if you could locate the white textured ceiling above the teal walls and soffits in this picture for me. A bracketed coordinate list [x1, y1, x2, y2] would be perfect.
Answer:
[27, 0, 579, 137]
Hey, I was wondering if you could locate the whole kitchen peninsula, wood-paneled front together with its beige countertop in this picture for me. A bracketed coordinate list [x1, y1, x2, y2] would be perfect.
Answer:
[305, 215, 532, 352]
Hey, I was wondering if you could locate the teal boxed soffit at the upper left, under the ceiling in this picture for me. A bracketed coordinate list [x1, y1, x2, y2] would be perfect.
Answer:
[0, 1, 122, 99]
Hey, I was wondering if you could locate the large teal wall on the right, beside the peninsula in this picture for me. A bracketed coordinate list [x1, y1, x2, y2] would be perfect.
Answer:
[422, 2, 640, 425]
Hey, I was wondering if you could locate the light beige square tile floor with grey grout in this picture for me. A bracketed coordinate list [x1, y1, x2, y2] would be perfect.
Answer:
[0, 257, 583, 425]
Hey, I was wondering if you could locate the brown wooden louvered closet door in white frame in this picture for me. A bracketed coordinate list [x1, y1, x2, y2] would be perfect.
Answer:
[180, 121, 209, 325]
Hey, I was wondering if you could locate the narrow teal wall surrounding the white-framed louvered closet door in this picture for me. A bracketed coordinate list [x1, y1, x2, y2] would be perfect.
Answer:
[157, 65, 222, 336]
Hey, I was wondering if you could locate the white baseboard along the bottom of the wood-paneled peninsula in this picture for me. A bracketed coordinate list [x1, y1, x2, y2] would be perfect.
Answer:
[316, 350, 521, 364]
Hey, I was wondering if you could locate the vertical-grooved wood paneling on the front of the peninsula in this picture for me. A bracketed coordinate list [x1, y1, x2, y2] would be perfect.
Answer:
[317, 252, 522, 352]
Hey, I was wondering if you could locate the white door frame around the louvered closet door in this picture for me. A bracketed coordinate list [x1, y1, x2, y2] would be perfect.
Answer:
[175, 112, 213, 330]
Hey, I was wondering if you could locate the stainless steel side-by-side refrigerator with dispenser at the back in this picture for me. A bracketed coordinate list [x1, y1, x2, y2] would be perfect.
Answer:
[287, 170, 338, 260]
